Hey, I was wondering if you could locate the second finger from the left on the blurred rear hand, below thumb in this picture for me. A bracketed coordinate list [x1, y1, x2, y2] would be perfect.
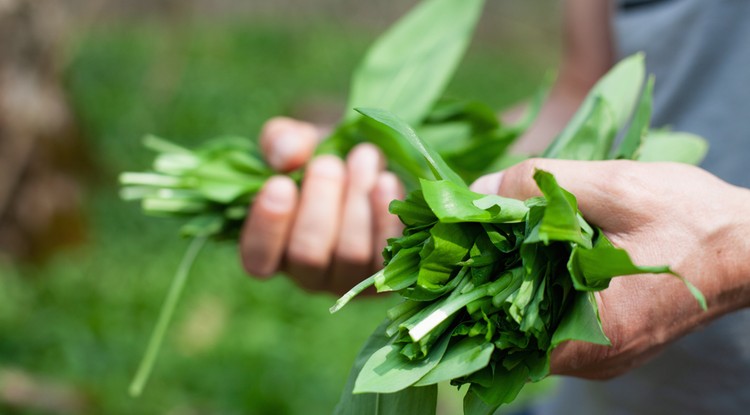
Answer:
[287, 155, 346, 290]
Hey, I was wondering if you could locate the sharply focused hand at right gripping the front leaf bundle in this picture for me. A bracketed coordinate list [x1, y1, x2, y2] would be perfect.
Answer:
[472, 159, 750, 379]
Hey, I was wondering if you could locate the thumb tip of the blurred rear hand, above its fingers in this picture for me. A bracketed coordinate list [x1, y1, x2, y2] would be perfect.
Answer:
[260, 117, 322, 172]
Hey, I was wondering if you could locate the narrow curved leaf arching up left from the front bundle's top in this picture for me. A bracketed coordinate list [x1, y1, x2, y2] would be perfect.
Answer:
[357, 108, 466, 187]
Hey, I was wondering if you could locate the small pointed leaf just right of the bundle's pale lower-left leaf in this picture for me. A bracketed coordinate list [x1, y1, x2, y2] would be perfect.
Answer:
[415, 337, 495, 386]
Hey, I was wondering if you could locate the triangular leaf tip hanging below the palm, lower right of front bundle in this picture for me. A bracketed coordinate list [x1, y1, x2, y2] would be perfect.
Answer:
[552, 292, 612, 348]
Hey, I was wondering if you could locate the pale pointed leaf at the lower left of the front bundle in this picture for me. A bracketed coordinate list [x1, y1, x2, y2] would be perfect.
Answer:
[354, 335, 450, 393]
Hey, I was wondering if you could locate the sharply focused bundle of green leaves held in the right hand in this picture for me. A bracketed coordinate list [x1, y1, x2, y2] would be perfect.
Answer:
[331, 55, 706, 414]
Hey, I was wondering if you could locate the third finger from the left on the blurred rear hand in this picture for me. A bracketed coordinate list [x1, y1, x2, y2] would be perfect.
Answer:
[330, 143, 385, 292]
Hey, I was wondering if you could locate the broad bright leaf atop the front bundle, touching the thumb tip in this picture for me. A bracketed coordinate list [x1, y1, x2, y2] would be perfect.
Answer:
[420, 180, 528, 223]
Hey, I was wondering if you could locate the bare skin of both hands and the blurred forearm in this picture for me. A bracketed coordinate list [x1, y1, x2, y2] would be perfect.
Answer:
[241, 0, 750, 379]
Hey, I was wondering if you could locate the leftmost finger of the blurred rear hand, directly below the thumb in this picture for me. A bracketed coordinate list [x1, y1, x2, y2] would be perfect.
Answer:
[240, 176, 297, 277]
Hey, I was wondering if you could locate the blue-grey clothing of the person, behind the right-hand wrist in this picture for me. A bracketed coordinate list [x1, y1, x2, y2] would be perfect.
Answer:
[534, 0, 750, 415]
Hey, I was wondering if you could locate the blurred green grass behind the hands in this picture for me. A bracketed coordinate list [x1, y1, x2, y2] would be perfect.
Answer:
[0, 16, 560, 414]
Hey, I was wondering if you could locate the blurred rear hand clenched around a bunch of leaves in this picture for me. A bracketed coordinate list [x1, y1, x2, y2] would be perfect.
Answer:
[240, 118, 403, 293]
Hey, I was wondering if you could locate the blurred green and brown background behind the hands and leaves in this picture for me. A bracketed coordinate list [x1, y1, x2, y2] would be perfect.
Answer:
[0, 0, 560, 415]
